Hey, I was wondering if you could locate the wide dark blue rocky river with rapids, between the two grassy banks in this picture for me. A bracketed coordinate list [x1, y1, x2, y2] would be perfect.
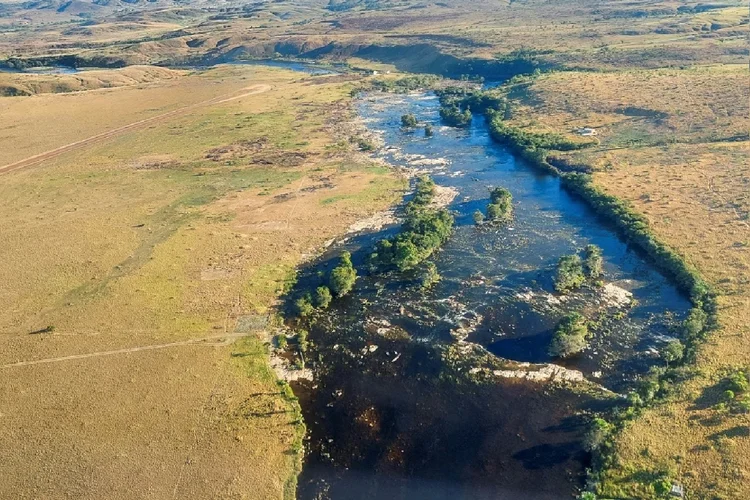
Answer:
[295, 93, 689, 500]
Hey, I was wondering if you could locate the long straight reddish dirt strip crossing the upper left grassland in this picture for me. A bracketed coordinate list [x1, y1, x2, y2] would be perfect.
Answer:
[0, 85, 272, 175]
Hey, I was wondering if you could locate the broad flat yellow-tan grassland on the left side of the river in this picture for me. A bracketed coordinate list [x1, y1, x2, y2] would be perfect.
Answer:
[0, 63, 402, 499]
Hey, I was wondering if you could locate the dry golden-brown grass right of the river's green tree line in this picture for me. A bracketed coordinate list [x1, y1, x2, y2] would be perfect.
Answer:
[511, 66, 750, 498]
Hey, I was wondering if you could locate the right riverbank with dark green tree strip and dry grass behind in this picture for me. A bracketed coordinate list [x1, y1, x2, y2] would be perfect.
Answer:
[472, 67, 750, 498]
